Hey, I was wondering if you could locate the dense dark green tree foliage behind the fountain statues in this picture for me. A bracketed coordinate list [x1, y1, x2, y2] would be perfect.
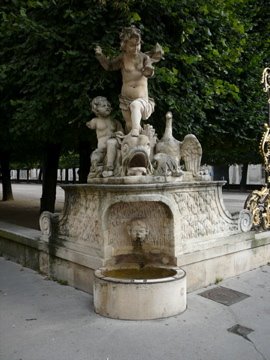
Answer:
[0, 0, 270, 163]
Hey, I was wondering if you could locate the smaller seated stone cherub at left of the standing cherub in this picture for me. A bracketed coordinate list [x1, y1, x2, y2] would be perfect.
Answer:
[86, 96, 124, 177]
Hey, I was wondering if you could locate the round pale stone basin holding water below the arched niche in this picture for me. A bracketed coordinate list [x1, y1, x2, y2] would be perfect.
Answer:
[94, 267, 186, 320]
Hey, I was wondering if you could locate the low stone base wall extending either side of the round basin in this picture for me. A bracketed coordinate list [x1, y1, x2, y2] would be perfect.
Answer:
[0, 223, 270, 293]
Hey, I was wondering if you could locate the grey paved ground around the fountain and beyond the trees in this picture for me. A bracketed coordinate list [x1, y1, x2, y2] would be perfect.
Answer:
[0, 184, 270, 360]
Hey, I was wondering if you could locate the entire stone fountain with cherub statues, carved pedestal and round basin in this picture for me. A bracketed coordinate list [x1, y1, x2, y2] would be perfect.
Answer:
[40, 27, 250, 320]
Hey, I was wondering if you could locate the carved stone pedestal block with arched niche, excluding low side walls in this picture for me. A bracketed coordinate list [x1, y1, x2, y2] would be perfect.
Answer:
[50, 177, 241, 269]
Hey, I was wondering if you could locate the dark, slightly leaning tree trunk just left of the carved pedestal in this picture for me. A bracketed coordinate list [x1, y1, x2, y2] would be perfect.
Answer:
[40, 144, 61, 213]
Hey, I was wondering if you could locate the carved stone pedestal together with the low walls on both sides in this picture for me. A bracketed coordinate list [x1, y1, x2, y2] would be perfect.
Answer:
[0, 177, 270, 293]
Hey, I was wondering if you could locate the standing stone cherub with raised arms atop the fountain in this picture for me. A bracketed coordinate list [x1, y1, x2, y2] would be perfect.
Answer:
[95, 26, 163, 136]
